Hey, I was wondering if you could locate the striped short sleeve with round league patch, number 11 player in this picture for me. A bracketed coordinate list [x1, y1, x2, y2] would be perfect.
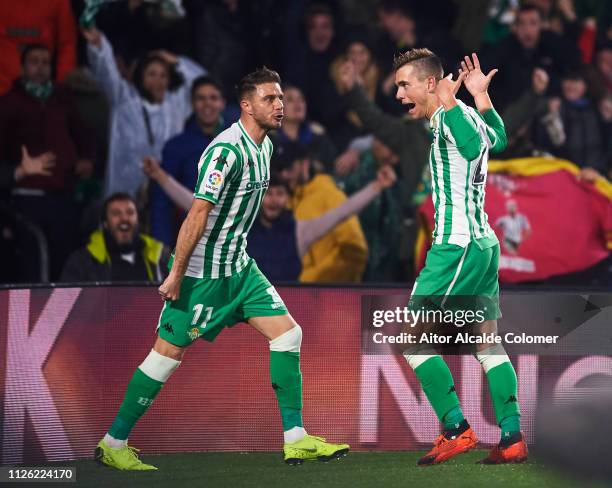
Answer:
[193, 143, 242, 205]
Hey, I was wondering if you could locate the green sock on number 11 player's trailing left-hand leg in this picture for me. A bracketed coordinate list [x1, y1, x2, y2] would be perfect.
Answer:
[108, 368, 164, 440]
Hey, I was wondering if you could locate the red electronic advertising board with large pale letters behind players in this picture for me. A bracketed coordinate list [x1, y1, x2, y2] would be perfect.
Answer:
[0, 288, 612, 464]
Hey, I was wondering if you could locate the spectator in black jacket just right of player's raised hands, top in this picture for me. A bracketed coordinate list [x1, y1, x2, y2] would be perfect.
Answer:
[483, 5, 580, 110]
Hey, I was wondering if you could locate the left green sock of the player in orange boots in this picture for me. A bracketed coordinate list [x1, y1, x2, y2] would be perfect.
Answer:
[414, 356, 463, 422]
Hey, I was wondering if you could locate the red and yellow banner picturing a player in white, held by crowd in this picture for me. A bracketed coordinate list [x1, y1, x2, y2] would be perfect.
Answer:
[418, 158, 612, 283]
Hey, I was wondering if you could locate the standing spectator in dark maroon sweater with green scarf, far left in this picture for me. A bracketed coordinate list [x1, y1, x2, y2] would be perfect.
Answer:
[0, 45, 95, 282]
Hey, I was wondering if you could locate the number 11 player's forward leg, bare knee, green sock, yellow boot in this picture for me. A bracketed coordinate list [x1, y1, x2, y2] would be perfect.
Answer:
[239, 262, 349, 465]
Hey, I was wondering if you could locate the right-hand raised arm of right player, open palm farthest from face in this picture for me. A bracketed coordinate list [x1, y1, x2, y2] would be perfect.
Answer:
[461, 53, 508, 152]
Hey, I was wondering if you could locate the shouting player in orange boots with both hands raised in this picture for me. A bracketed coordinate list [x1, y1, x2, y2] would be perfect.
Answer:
[394, 49, 527, 465]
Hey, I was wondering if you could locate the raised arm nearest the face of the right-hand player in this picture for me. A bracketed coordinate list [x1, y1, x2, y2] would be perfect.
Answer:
[436, 71, 480, 161]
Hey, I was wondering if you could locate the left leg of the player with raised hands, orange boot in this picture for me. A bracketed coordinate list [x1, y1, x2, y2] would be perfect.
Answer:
[404, 246, 478, 466]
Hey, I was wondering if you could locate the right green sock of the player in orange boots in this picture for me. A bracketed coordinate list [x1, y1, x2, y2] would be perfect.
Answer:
[486, 361, 521, 439]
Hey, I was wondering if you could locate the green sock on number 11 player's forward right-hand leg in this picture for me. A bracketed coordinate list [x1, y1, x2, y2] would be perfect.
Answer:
[270, 351, 304, 431]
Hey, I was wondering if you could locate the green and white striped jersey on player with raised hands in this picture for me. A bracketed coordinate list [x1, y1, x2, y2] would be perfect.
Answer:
[429, 101, 506, 247]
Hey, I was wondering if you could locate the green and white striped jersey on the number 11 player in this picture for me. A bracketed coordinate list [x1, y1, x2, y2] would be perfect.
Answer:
[185, 121, 272, 278]
